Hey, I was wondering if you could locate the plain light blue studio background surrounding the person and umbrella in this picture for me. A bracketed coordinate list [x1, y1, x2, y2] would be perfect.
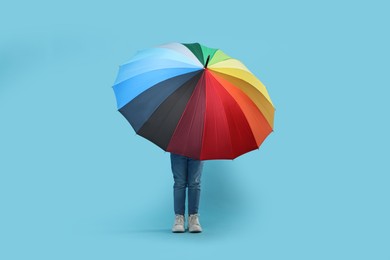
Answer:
[0, 0, 390, 260]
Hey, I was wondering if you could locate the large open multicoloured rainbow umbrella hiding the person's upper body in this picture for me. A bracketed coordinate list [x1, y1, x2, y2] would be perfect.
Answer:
[113, 43, 275, 160]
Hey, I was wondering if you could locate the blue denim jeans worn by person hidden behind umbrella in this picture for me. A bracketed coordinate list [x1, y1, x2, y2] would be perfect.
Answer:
[171, 153, 203, 215]
